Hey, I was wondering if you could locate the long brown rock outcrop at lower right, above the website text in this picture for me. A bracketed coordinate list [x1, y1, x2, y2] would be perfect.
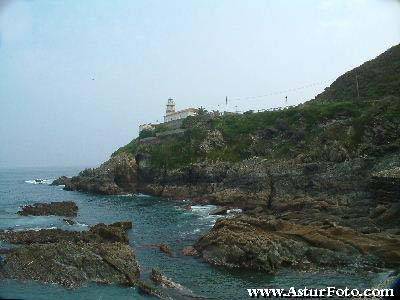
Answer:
[195, 215, 400, 273]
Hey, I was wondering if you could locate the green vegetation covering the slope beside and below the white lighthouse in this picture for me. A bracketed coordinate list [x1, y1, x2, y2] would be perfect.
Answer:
[118, 98, 400, 168]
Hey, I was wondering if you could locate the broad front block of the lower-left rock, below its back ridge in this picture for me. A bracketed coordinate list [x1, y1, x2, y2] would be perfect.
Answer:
[0, 241, 139, 287]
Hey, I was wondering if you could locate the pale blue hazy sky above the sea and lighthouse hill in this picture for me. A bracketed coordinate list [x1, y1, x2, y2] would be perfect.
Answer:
[0, 0, 400, 167]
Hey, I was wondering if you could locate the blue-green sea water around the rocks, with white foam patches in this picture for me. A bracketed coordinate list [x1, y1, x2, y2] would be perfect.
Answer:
[0, 168, 386, 300]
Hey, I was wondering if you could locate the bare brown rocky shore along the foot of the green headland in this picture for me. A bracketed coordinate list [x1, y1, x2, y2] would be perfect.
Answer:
[49, 154, 400, 273]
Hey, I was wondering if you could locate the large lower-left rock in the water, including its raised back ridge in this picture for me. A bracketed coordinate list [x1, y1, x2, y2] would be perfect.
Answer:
[0, 223, 139, 288]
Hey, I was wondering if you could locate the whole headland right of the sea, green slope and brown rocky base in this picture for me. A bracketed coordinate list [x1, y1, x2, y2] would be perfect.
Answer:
[50, 46, 400, 273]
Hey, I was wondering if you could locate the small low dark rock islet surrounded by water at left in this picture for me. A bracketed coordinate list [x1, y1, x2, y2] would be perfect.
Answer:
[18, 201, 78, 217]
